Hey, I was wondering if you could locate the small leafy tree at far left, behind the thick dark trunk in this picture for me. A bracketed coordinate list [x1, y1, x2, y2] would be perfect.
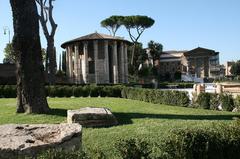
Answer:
[3, 43, 16, 64]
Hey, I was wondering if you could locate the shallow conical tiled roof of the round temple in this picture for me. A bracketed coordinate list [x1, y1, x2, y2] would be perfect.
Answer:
[61, 32, 130, 48]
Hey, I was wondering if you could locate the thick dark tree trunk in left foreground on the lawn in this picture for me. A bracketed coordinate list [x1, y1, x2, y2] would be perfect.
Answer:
[10, 0, 49, 113]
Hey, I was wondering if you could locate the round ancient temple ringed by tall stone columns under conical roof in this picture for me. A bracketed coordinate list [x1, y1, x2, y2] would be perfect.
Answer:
[62, 32, 131, 84]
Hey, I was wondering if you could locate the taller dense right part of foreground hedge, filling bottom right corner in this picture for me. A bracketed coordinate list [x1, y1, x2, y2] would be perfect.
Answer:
[160, 120, 240, 159]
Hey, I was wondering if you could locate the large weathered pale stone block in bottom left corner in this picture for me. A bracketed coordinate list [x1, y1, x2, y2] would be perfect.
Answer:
[0, 124, 82, 159]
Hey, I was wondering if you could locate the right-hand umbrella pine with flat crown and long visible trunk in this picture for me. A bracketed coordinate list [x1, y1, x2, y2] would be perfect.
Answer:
[122, 15, 155, 65]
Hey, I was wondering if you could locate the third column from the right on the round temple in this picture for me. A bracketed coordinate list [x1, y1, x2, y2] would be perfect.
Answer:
[113, 41, 118, 84]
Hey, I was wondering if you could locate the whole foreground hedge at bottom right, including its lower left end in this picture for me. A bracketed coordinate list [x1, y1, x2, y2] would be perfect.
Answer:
[115, 121, 240, 159]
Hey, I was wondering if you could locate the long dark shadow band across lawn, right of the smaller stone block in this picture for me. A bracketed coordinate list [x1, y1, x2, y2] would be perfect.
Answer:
[113, 112, 240, 125]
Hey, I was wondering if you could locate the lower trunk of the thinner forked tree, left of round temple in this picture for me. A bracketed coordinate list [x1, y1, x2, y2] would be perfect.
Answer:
[47, 37, 56, 85]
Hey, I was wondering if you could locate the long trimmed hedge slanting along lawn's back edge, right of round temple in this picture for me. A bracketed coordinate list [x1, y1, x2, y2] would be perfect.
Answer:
[122, 87, 190, 107]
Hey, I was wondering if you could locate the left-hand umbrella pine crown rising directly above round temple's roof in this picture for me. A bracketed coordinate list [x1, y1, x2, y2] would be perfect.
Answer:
[101, 15, 124, 36]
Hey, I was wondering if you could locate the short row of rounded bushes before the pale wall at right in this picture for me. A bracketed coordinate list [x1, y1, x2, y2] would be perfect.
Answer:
[193, 93, 235, 111]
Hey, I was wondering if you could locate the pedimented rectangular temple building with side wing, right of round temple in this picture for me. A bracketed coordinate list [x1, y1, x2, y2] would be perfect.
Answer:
[147, 47, 220, 82]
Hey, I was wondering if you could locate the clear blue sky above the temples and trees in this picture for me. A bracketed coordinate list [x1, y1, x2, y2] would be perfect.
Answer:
[0, 0, 240, 63]
